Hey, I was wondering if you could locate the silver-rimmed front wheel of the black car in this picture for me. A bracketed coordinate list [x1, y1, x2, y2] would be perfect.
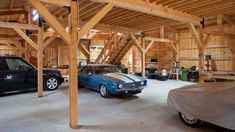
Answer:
[44, 76, 59, 91]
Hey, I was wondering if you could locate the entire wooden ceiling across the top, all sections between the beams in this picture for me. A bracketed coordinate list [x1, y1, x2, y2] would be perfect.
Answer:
[0, 0, 235, 31]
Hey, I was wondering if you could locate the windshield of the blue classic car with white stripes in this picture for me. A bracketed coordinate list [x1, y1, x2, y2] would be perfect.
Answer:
[94, 66, 120, 74]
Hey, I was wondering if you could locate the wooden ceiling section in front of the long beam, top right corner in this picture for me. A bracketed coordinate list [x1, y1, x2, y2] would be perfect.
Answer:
[144, 0, 235, 17]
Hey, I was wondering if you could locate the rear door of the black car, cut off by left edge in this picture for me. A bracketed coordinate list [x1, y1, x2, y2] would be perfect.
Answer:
[0, 58, 9, 93]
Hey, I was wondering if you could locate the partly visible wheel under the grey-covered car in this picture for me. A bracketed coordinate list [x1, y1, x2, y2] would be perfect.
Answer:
[179, 112, 203, 127]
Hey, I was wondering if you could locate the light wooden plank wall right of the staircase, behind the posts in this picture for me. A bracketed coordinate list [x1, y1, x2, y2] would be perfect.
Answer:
[122, 25, 235, 72]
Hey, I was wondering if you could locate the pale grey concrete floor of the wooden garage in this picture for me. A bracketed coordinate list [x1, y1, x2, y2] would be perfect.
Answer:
[0, 80, 232, 132]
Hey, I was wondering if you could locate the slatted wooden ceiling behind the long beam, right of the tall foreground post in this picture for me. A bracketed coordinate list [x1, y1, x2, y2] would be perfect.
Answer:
[80, 0, 180, 30]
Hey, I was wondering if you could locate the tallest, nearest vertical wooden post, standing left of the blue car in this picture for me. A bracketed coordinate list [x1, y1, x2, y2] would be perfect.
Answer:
[69, 0, 78, 129]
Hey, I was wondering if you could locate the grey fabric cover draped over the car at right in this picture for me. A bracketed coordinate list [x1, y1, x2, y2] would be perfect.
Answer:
[167, 82, 235, 130]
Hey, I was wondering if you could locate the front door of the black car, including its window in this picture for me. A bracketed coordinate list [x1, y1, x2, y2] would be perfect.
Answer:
[4, 58, 28, 91]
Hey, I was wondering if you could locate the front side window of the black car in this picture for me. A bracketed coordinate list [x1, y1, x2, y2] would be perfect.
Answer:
[6, 59, 32, 71]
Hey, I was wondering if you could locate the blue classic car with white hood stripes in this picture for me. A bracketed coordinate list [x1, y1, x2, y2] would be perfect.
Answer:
[78, 64, 147, 98]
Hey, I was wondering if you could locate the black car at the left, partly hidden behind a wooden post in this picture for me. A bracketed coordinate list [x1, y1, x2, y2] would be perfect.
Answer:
[0, 56, 64, 93]
